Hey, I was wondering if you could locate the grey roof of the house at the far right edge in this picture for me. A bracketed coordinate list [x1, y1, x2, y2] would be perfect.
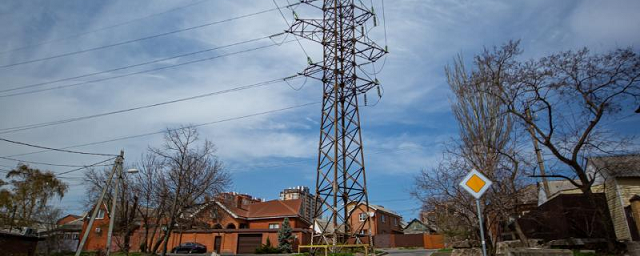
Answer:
[589, 154, 640, 178]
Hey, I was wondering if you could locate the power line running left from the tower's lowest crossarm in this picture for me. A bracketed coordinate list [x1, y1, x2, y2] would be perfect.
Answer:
[0, 75, 298, 134]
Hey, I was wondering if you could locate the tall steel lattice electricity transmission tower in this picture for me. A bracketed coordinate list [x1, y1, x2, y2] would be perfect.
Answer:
[287, 0, 387, 251]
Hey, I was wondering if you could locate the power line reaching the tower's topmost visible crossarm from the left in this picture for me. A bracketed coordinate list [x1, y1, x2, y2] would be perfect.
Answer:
[0, 3, 297, 68]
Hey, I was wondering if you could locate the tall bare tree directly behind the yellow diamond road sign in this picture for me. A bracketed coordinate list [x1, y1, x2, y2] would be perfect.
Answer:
[415, 51, 531, 250]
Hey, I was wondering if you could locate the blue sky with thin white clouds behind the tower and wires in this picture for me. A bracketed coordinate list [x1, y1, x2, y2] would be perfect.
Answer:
[0, 0, 640, 220]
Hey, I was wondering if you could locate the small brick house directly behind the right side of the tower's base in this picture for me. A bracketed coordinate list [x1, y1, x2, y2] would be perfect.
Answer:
[347, 203, 402, 236]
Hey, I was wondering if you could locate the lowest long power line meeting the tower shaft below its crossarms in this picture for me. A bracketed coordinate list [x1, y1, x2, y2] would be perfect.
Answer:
[0, 102, 320, 158]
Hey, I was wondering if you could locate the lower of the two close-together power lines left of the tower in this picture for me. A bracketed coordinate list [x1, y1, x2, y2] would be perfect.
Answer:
[0, 41, 292, 98]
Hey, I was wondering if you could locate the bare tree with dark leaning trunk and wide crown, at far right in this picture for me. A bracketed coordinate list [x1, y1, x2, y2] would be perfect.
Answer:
[475, 42, 640, 249]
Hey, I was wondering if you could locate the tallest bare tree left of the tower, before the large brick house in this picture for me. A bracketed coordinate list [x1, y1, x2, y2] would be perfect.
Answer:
[150, 126, 230, 255]
